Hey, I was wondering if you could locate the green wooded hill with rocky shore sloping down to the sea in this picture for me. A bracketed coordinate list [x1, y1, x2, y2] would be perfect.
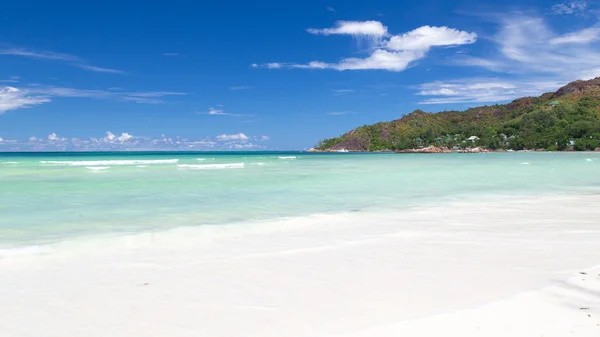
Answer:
[315, 77, 600, 151]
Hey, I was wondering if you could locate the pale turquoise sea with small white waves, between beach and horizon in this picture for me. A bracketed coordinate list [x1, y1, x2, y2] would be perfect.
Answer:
[0, 152, 600, 249]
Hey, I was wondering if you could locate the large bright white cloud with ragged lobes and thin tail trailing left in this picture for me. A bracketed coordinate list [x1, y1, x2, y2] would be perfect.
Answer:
[252, 21, 477, 71]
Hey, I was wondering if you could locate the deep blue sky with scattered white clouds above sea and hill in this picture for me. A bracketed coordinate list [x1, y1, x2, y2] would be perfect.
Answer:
[0, 0, 600, 150]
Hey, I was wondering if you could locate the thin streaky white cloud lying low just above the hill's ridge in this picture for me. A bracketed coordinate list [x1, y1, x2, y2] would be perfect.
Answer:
[417, 78, 565, 104]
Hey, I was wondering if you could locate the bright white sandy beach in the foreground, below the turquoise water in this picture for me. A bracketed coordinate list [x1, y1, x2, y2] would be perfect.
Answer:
[0, 195, 600, 337]
